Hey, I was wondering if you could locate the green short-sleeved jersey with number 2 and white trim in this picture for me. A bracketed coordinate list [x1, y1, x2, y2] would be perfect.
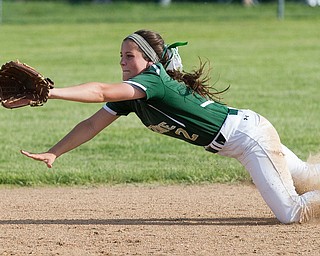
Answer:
[105, 63, 228, 146]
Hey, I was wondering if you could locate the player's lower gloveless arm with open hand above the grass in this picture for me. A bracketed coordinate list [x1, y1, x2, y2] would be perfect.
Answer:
[21, 109, 118, 168]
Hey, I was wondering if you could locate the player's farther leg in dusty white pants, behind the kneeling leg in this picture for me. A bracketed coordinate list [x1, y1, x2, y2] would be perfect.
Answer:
[282, 145, 320, 195]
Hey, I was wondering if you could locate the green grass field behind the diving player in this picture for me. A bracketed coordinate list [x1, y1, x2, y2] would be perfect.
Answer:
[0, 1, 320, 186]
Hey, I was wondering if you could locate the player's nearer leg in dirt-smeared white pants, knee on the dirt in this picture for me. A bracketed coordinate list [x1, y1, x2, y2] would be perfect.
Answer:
[239, 117, 320, 223]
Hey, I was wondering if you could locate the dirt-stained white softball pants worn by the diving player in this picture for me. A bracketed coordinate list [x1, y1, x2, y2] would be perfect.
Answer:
[218, 110, 320, 223]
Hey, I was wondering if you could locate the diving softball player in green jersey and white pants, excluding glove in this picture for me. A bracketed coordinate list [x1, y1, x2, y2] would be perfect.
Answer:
[21, 30, 320, 223]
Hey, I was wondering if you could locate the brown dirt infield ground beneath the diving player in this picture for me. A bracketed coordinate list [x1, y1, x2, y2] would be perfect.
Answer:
[0, 184, 320, 256]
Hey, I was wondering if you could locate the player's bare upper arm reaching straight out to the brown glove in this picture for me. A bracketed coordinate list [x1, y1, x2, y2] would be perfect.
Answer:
[49, 82, 145, 103]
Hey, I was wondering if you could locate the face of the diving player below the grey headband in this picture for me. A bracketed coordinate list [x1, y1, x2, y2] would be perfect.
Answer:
[120, 40, 150, 81]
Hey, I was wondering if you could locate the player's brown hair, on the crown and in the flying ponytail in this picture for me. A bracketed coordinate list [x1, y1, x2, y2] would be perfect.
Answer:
[128, 30, 229, 101]
